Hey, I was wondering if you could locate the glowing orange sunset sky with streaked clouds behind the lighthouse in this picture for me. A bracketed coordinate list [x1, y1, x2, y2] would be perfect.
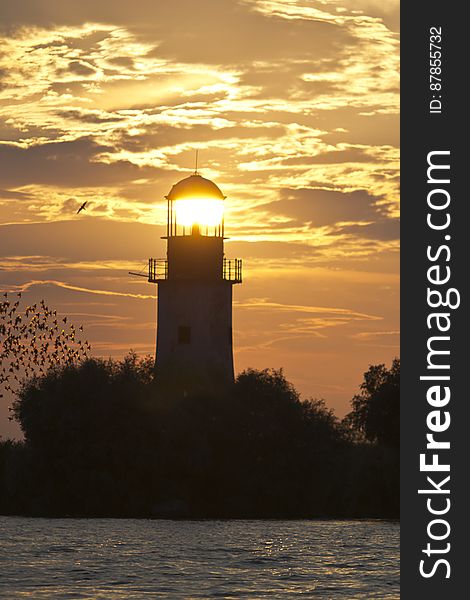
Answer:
[0, 0, 399, 435]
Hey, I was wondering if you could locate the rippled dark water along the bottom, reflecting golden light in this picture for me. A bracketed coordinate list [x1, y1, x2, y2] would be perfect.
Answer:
[0, 517, 399, 600]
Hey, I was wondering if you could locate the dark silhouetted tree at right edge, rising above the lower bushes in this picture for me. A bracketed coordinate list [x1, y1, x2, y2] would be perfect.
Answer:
[345, 358, 400, 448]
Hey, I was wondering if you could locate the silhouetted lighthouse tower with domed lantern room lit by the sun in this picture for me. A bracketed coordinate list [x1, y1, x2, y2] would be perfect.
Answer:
[148, 171, 242, 389]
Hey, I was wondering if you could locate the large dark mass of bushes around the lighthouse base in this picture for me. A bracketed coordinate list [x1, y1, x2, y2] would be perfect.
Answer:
[0, 355, 398, 518]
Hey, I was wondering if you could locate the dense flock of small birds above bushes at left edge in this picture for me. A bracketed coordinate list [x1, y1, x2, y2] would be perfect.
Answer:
[0, 292, 91, 420]
